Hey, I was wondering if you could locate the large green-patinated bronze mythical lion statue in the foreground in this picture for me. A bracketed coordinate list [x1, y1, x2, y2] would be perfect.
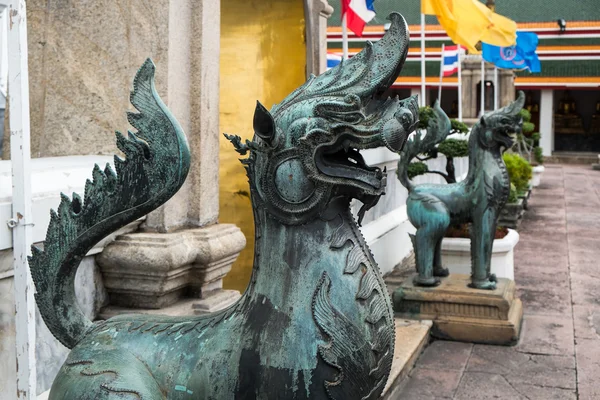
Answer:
[31, 14, 418, 400]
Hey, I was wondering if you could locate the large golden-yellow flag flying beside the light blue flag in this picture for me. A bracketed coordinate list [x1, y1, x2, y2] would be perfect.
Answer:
[421, 0, 517, 53]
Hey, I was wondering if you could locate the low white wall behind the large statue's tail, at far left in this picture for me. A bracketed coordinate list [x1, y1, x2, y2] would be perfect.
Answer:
[0, 156, 140, 400]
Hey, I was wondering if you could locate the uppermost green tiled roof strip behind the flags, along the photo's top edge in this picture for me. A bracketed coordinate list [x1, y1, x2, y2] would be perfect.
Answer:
[328, 0, 600, 26]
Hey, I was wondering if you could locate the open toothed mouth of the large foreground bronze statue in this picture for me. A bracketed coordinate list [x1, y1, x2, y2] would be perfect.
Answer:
[315, 138, 386, 194]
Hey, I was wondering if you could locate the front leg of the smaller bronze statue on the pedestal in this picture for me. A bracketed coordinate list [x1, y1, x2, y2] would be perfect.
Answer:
[469, 208, 496, 290]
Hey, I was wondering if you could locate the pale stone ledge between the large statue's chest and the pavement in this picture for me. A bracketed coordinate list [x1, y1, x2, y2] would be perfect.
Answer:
[381, 318, 432, 400]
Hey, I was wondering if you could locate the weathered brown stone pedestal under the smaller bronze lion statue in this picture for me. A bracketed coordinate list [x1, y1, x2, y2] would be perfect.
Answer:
[393, 274, 523, 345]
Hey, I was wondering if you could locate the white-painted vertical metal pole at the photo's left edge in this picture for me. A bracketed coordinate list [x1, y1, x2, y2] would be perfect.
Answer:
[8, 0, 37, 400]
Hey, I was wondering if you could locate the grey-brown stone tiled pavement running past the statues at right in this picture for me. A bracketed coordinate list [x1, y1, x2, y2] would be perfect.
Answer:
[397, 165, 600, 400]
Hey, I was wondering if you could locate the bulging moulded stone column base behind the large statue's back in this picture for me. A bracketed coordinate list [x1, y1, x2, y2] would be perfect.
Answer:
[96, 224, 246, 313]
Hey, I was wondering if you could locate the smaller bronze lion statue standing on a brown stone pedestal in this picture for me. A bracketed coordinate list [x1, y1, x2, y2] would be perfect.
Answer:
[397, 92, 525, 290]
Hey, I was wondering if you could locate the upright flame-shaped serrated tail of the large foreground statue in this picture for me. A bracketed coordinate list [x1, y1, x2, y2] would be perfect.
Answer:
[29, 59, 190, 348]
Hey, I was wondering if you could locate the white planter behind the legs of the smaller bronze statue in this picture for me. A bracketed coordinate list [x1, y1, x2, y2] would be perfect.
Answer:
[442, 229, 519, 280]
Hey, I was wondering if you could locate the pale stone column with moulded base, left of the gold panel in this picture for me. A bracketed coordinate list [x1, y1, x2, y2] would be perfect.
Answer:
[97, 0, 246, 312]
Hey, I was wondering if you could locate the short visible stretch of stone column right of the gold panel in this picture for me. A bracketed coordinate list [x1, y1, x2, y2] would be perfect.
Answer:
[304, 0, 333, 76]
